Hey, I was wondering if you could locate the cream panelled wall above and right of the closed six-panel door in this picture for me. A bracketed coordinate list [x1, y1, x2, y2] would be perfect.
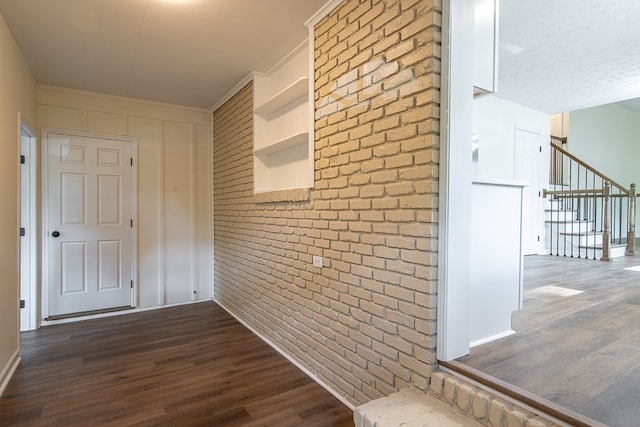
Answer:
[37, 86, 213, 307]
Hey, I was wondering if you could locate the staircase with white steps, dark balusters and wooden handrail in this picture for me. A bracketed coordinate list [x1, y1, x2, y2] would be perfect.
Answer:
[544, 137, 636, 261]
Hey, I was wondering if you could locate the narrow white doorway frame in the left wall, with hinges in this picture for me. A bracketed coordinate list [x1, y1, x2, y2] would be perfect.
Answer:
[19, 117, 39, 332]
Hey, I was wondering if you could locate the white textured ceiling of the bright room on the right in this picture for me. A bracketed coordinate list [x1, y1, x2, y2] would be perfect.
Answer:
[498, 0, 640, 113]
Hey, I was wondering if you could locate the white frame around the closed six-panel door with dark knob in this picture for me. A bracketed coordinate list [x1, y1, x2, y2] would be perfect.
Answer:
[41, 128, 138, 320]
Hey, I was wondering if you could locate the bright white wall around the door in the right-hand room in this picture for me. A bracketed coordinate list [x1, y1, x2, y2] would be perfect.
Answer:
[469, 95, 550, 179]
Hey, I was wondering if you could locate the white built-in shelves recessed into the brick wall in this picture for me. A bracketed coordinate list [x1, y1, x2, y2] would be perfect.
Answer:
[253, 41, 314, 193]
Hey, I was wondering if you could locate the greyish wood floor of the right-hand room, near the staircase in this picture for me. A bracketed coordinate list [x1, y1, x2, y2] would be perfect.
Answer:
[458, 256, 640, 427]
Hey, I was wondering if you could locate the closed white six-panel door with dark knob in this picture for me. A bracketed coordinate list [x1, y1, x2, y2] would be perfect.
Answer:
[44, 132, 133, 316]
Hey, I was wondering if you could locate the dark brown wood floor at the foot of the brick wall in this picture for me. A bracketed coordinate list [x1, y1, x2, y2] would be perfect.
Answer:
[0, 302, 354, 426]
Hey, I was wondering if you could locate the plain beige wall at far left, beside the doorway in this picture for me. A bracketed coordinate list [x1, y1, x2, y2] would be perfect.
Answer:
[0, 11, 36, 391]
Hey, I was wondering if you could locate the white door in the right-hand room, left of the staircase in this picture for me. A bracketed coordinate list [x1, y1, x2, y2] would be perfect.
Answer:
[514, 127, 542, 255]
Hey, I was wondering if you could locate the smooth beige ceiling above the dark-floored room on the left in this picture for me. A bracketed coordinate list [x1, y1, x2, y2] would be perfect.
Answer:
[0, 0, 326, 108]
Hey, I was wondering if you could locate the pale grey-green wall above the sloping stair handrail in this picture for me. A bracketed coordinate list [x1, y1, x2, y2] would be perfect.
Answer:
[568, 104, 640, 187]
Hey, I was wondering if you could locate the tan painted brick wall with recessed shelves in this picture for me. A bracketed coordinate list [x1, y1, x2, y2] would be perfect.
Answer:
[214, 0, 440, 404]
